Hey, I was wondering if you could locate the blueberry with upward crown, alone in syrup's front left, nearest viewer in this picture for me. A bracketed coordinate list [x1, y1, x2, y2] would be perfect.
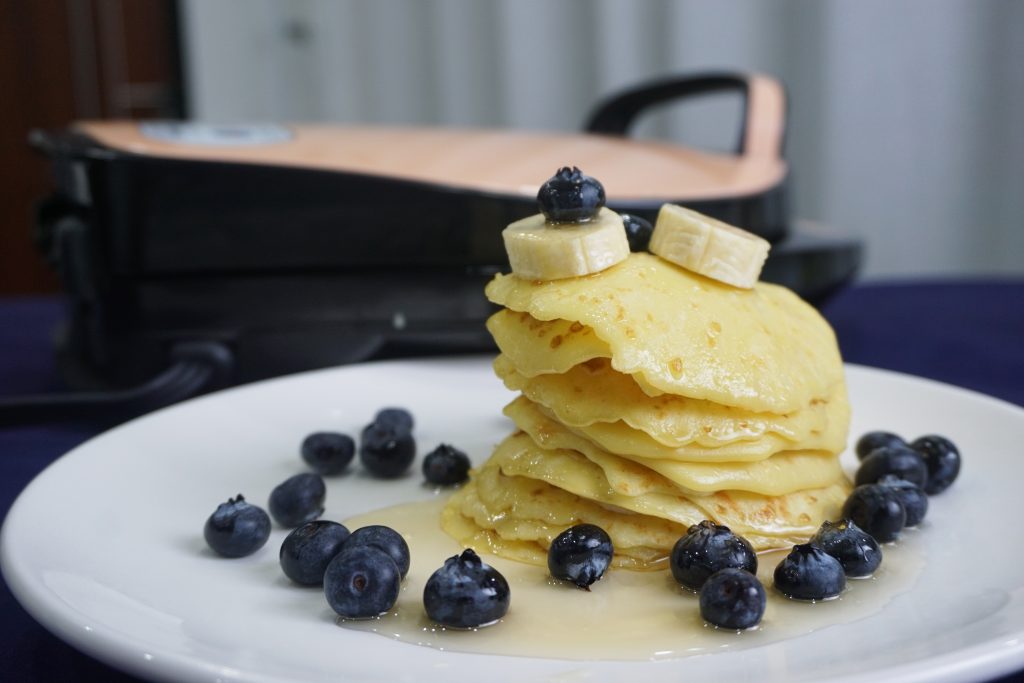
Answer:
[423, 549, 511, 629]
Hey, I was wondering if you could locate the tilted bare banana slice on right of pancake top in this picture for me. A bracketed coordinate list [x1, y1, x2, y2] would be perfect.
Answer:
[650, 204, 771, 289]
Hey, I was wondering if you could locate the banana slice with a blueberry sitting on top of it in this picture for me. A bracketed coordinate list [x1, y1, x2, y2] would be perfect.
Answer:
[502, 208, 630, 280]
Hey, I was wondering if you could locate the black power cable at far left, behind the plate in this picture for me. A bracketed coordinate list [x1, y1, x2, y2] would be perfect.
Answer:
[0, 342, 231, 427]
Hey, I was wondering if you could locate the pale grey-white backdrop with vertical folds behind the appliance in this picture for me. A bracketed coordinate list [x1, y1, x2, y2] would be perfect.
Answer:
[184, 0, 1024, 279]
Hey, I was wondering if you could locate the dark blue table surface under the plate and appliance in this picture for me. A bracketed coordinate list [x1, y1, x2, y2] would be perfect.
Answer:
[0, 280, 1024, 683]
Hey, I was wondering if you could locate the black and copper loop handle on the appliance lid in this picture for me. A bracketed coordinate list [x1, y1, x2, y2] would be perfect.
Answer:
[584, 73, 786, 159]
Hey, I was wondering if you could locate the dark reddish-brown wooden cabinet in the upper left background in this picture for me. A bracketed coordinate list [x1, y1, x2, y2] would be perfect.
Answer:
[0, 0, 185, 295]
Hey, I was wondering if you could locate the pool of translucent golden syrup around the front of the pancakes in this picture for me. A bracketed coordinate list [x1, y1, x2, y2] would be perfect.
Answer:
[338, 500, 925, 659]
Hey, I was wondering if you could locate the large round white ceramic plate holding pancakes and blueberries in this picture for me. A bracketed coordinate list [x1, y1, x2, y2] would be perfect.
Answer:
[0, 358, 1024, 683]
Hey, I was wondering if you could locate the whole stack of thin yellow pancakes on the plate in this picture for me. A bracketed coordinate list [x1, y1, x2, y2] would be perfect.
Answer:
[442, 253, 850, 568]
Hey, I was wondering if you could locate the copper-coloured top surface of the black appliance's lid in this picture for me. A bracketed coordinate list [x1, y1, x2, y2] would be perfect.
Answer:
[75, 77, 786, 204]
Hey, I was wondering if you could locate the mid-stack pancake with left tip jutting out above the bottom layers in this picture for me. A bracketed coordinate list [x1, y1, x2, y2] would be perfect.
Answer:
[505, 396, 846, 496]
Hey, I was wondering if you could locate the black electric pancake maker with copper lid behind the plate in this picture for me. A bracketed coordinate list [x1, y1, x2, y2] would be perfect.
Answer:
[25, 74, 860, 420]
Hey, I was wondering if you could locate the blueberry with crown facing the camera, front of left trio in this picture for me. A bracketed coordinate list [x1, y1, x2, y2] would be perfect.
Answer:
[324, 546, 401, 618]
